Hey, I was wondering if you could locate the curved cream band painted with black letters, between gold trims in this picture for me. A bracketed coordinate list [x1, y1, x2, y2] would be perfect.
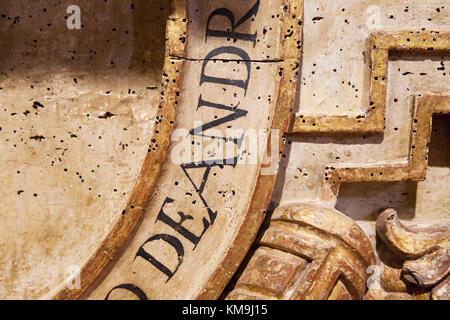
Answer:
[88, 0, 282, 299]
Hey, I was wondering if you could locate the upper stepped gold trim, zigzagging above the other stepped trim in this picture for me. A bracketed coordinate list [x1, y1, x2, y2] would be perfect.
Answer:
[291, 31, 450, 134]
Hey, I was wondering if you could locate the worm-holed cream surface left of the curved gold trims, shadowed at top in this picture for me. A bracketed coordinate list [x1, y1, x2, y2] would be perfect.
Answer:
[0, 1, 170, 299]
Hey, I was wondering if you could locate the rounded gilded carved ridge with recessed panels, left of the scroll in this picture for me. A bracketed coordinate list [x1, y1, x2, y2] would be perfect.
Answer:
[227, 204, 375, 300]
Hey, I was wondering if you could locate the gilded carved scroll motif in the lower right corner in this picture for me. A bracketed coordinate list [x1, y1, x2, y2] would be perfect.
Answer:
[366, 209, 450, 300]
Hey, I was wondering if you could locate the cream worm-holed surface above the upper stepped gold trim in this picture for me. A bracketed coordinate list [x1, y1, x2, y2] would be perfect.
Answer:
[297, 0, 450, 115]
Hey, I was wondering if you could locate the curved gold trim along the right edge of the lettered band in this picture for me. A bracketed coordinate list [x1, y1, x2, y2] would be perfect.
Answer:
[196, 0, 303, 300]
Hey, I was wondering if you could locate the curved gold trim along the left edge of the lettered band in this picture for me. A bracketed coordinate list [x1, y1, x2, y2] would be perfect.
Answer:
[53, 0, 187, 300]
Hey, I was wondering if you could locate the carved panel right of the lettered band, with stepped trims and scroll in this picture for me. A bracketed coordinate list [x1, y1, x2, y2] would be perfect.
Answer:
[228, 1, 450, 299]
